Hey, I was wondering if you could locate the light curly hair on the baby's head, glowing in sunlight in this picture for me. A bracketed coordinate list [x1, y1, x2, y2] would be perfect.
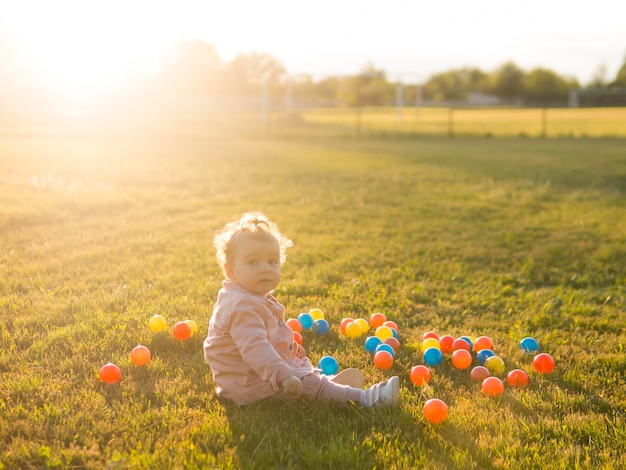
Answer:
[213, 211, 293, 274]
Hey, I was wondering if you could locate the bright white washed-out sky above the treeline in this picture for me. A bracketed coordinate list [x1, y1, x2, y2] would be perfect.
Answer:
[0, 0, 626, 97]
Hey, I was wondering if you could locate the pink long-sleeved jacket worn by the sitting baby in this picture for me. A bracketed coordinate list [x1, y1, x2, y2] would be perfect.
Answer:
[204, 281, 315, 405]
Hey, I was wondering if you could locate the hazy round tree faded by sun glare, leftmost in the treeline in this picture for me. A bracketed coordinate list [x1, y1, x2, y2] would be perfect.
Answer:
[161, 40, 223, 95]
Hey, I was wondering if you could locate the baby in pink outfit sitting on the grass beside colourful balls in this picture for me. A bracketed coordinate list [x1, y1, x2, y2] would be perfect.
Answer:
[204, 212, 399, 407]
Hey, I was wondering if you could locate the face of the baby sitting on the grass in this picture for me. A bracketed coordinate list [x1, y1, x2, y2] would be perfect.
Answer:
[225, 234, 280, 295]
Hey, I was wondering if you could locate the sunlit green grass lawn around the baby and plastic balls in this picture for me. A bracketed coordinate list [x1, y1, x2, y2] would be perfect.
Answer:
[0, 134, 626, 469]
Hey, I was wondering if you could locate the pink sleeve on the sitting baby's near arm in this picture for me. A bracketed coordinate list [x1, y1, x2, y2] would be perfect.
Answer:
[230, 310, 293, 391]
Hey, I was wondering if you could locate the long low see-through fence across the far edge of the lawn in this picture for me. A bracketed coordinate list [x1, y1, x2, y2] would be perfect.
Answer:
[0, 103, 626, 138]
